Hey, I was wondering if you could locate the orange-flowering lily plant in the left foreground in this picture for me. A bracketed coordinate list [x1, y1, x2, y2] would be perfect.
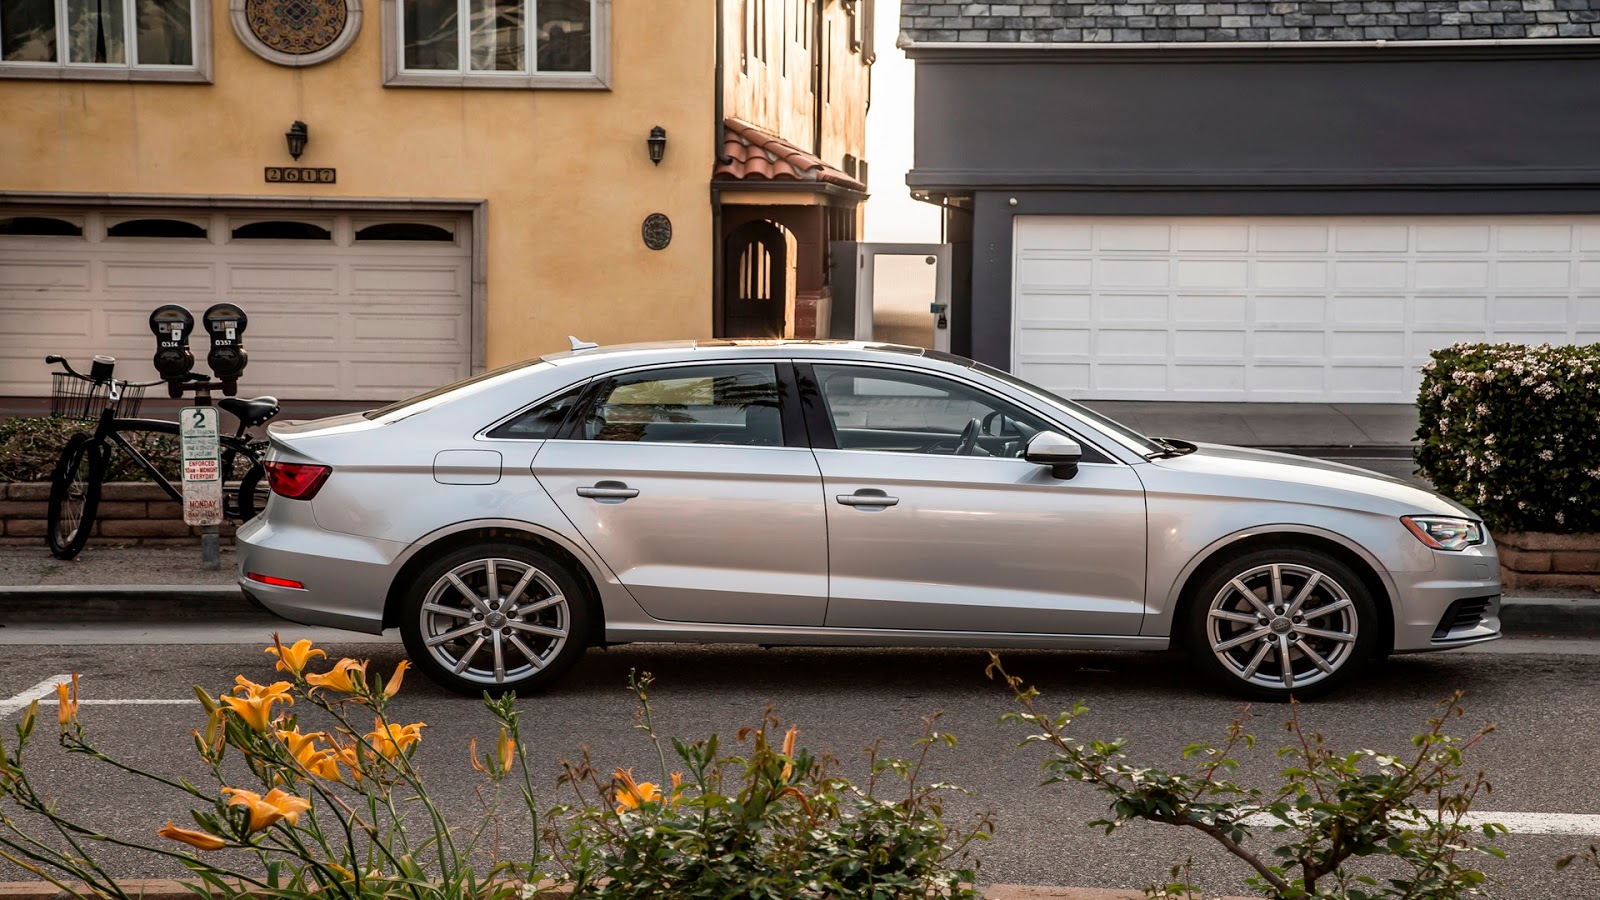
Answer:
[0, 639, 556, 900]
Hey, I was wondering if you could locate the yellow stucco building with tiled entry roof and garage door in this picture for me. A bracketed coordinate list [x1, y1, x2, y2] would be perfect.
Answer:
[0, 0, 872, 400]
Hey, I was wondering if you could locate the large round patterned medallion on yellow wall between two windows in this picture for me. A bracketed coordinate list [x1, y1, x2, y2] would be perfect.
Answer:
[229, 0, 362, 66]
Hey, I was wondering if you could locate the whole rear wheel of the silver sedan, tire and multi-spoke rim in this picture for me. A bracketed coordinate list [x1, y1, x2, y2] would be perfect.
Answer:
[400, 541, 590, 697]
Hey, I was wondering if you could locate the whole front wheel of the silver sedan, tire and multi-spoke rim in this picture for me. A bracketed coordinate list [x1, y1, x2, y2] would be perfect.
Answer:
[1181, 548, 1381, 701]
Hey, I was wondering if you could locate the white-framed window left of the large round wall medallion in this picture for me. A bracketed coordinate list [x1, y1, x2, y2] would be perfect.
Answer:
[0, 0, 211, 82]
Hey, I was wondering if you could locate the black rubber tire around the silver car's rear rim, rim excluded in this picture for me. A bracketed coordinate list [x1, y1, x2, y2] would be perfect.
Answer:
[400, 541, 592, 697]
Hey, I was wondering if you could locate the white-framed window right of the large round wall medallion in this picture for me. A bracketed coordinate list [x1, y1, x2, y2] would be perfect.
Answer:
[384, 0, 611, 90]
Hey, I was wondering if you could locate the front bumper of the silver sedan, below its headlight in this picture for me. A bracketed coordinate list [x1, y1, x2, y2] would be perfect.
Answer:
[1392, 538, 1501, 653]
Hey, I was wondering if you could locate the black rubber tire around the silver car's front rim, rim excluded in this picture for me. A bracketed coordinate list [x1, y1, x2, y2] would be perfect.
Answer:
[1181, 548, 1381, 703]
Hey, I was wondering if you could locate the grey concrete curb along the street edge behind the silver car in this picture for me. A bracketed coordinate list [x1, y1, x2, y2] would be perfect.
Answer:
[0, 585, 1600, 637]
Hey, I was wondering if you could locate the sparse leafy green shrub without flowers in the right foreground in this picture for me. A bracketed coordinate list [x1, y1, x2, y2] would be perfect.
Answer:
[989, 655, 1506, 900]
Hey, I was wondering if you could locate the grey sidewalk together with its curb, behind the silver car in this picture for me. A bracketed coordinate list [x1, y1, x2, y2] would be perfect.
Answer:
[0, 540, 1600, 637]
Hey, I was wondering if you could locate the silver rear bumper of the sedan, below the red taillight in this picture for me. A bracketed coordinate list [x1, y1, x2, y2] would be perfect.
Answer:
[234, 509, 405, 634]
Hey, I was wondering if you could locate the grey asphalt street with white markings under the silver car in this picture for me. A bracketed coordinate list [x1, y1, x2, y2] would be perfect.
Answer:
[0, 629, 1600, 900]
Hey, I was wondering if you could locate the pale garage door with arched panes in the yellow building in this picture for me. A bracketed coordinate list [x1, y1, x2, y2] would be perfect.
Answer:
[0, 210, 472, 400]
